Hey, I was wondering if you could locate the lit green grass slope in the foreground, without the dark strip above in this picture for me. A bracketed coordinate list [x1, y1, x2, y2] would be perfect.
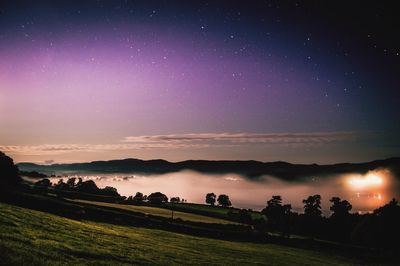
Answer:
[0, 203, 352, 265]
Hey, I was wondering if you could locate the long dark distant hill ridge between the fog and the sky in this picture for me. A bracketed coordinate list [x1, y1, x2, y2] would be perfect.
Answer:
[17, 157, 400, 181]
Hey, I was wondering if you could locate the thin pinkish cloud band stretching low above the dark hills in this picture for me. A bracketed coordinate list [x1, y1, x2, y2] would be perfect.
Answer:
[0, 132, 374, 155]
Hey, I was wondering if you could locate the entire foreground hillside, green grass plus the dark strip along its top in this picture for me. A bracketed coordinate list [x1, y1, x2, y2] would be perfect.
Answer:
[0, 191, 396, 265]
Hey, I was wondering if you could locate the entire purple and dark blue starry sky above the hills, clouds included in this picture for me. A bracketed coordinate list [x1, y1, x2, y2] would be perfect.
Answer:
[0, 0, 400, 163]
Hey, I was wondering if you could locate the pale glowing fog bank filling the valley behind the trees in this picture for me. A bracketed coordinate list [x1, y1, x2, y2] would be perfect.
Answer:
[47, 169, 399, 214]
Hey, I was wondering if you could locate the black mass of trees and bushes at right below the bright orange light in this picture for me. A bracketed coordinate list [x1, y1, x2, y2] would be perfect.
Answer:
[239, 194, 400, 248]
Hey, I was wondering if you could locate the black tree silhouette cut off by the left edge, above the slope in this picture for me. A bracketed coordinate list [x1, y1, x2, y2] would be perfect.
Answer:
[0, 151, 22, 190]
